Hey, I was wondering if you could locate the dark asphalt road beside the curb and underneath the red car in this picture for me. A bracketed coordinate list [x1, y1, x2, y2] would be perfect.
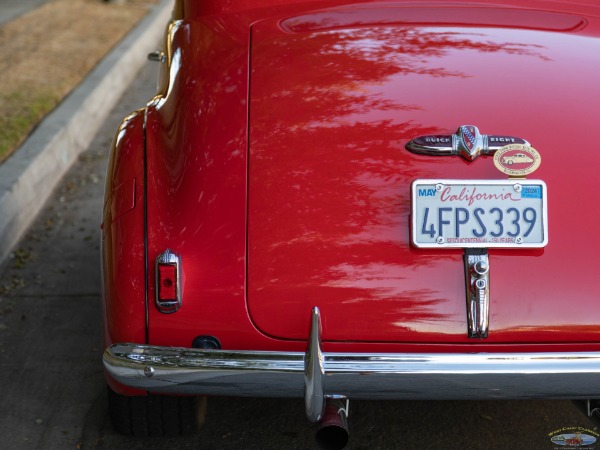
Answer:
[0, 64, 596, 450]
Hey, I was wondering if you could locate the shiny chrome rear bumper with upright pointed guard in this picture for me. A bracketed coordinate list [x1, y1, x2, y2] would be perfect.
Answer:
[104, 308, 600, 420]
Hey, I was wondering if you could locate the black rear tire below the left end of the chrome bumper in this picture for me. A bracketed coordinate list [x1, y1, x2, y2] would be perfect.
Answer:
[108, 387, 206, 437]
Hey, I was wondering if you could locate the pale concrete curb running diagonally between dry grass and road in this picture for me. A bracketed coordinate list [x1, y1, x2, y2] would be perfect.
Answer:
[0, 0, 172, 261]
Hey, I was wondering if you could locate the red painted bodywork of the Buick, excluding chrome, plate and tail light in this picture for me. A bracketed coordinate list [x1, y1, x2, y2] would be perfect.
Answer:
[103, 0, 600, 370]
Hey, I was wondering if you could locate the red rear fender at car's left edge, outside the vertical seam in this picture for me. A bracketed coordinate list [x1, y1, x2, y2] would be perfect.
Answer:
[102, 111, 146, 394]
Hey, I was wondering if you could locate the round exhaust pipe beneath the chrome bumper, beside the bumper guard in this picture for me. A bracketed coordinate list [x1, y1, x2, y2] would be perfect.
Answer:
[315, 397, 349, 450]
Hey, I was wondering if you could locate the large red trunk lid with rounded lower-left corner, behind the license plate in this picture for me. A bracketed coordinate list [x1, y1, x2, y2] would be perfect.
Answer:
[247, 3, 600, 343]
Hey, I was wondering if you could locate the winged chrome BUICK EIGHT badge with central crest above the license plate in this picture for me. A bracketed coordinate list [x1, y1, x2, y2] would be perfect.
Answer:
[406, 125, 529, 161]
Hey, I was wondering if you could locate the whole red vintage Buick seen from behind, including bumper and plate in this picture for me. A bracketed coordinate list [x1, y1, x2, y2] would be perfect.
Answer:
[102, 0, 600, 447]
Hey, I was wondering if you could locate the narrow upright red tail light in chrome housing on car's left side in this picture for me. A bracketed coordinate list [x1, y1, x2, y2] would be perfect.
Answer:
[156, 249, 181, 314]
